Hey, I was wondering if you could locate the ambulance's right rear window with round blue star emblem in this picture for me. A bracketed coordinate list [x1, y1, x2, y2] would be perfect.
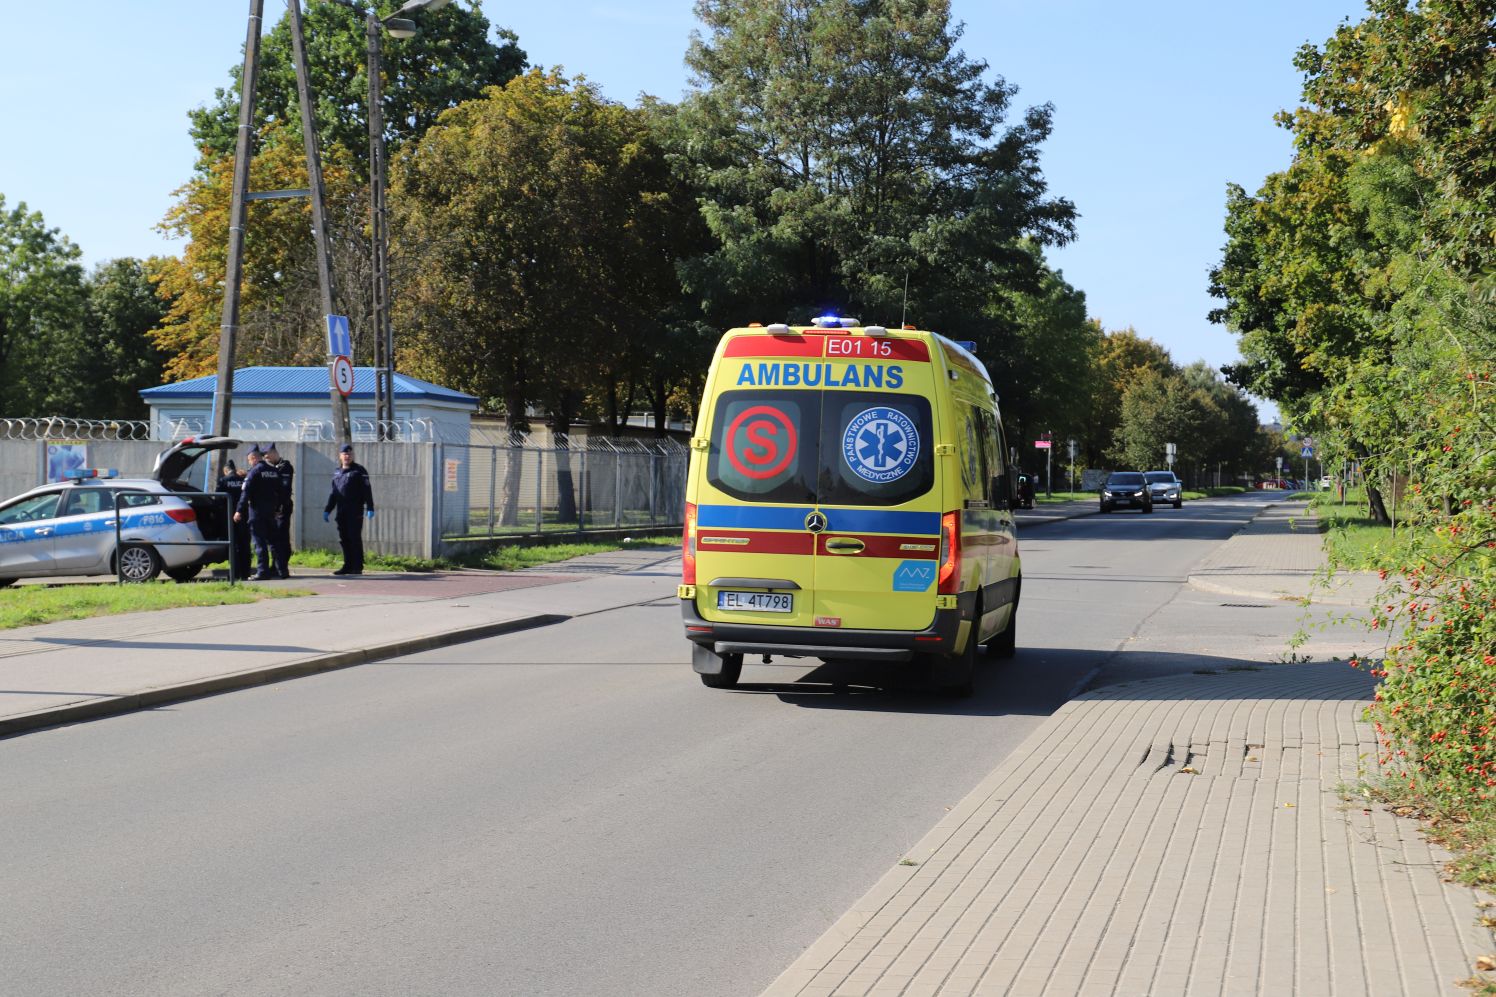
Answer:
[817, 391, 935, 506]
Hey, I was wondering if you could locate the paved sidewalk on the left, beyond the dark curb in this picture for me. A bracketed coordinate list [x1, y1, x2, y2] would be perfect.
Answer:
[0, 548, 679, 737]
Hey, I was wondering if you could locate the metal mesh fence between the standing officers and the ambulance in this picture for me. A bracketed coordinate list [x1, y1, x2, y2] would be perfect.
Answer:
[437, 436, 690, 540]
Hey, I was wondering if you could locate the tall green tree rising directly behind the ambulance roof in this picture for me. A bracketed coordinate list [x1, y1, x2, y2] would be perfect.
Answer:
[676, 0, 1074, 333]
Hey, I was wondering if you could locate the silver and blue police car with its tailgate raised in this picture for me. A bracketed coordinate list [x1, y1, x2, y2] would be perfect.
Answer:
[0, 437, 242, 588]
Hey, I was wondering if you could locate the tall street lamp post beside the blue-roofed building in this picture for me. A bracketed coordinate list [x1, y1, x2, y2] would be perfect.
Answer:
[337, 0, 449, 440]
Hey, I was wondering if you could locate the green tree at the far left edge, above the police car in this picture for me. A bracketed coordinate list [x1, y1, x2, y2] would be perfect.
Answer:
[0, 195, 85, 416]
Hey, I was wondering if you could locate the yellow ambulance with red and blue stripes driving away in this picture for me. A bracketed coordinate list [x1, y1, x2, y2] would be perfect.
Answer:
[679, 317, 1022, 695]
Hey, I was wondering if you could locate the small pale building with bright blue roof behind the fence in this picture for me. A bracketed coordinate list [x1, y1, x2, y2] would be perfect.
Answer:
[141, 367, 477, 443]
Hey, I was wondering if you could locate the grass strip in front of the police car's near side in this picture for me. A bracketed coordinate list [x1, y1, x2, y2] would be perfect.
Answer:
[0, 582, 302, 630]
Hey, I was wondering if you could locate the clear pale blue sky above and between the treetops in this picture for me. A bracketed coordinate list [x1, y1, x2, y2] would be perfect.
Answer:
[0, 0, 1364, 416]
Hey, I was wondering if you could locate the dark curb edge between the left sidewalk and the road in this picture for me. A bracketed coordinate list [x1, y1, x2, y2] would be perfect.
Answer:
[0, 604, 571, 738]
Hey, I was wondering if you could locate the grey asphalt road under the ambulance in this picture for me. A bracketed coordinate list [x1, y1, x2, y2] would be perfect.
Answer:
[0, 497, 1370, 997]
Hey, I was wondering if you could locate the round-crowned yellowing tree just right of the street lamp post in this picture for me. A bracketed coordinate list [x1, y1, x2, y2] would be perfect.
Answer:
[390, 70, 694, 518]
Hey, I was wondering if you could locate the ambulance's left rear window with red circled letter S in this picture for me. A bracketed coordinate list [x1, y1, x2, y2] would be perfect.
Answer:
[706, 391, 821, 501]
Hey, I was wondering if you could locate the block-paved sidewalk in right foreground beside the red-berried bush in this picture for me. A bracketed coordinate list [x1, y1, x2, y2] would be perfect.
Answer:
[766, 663, 1493, 997]
